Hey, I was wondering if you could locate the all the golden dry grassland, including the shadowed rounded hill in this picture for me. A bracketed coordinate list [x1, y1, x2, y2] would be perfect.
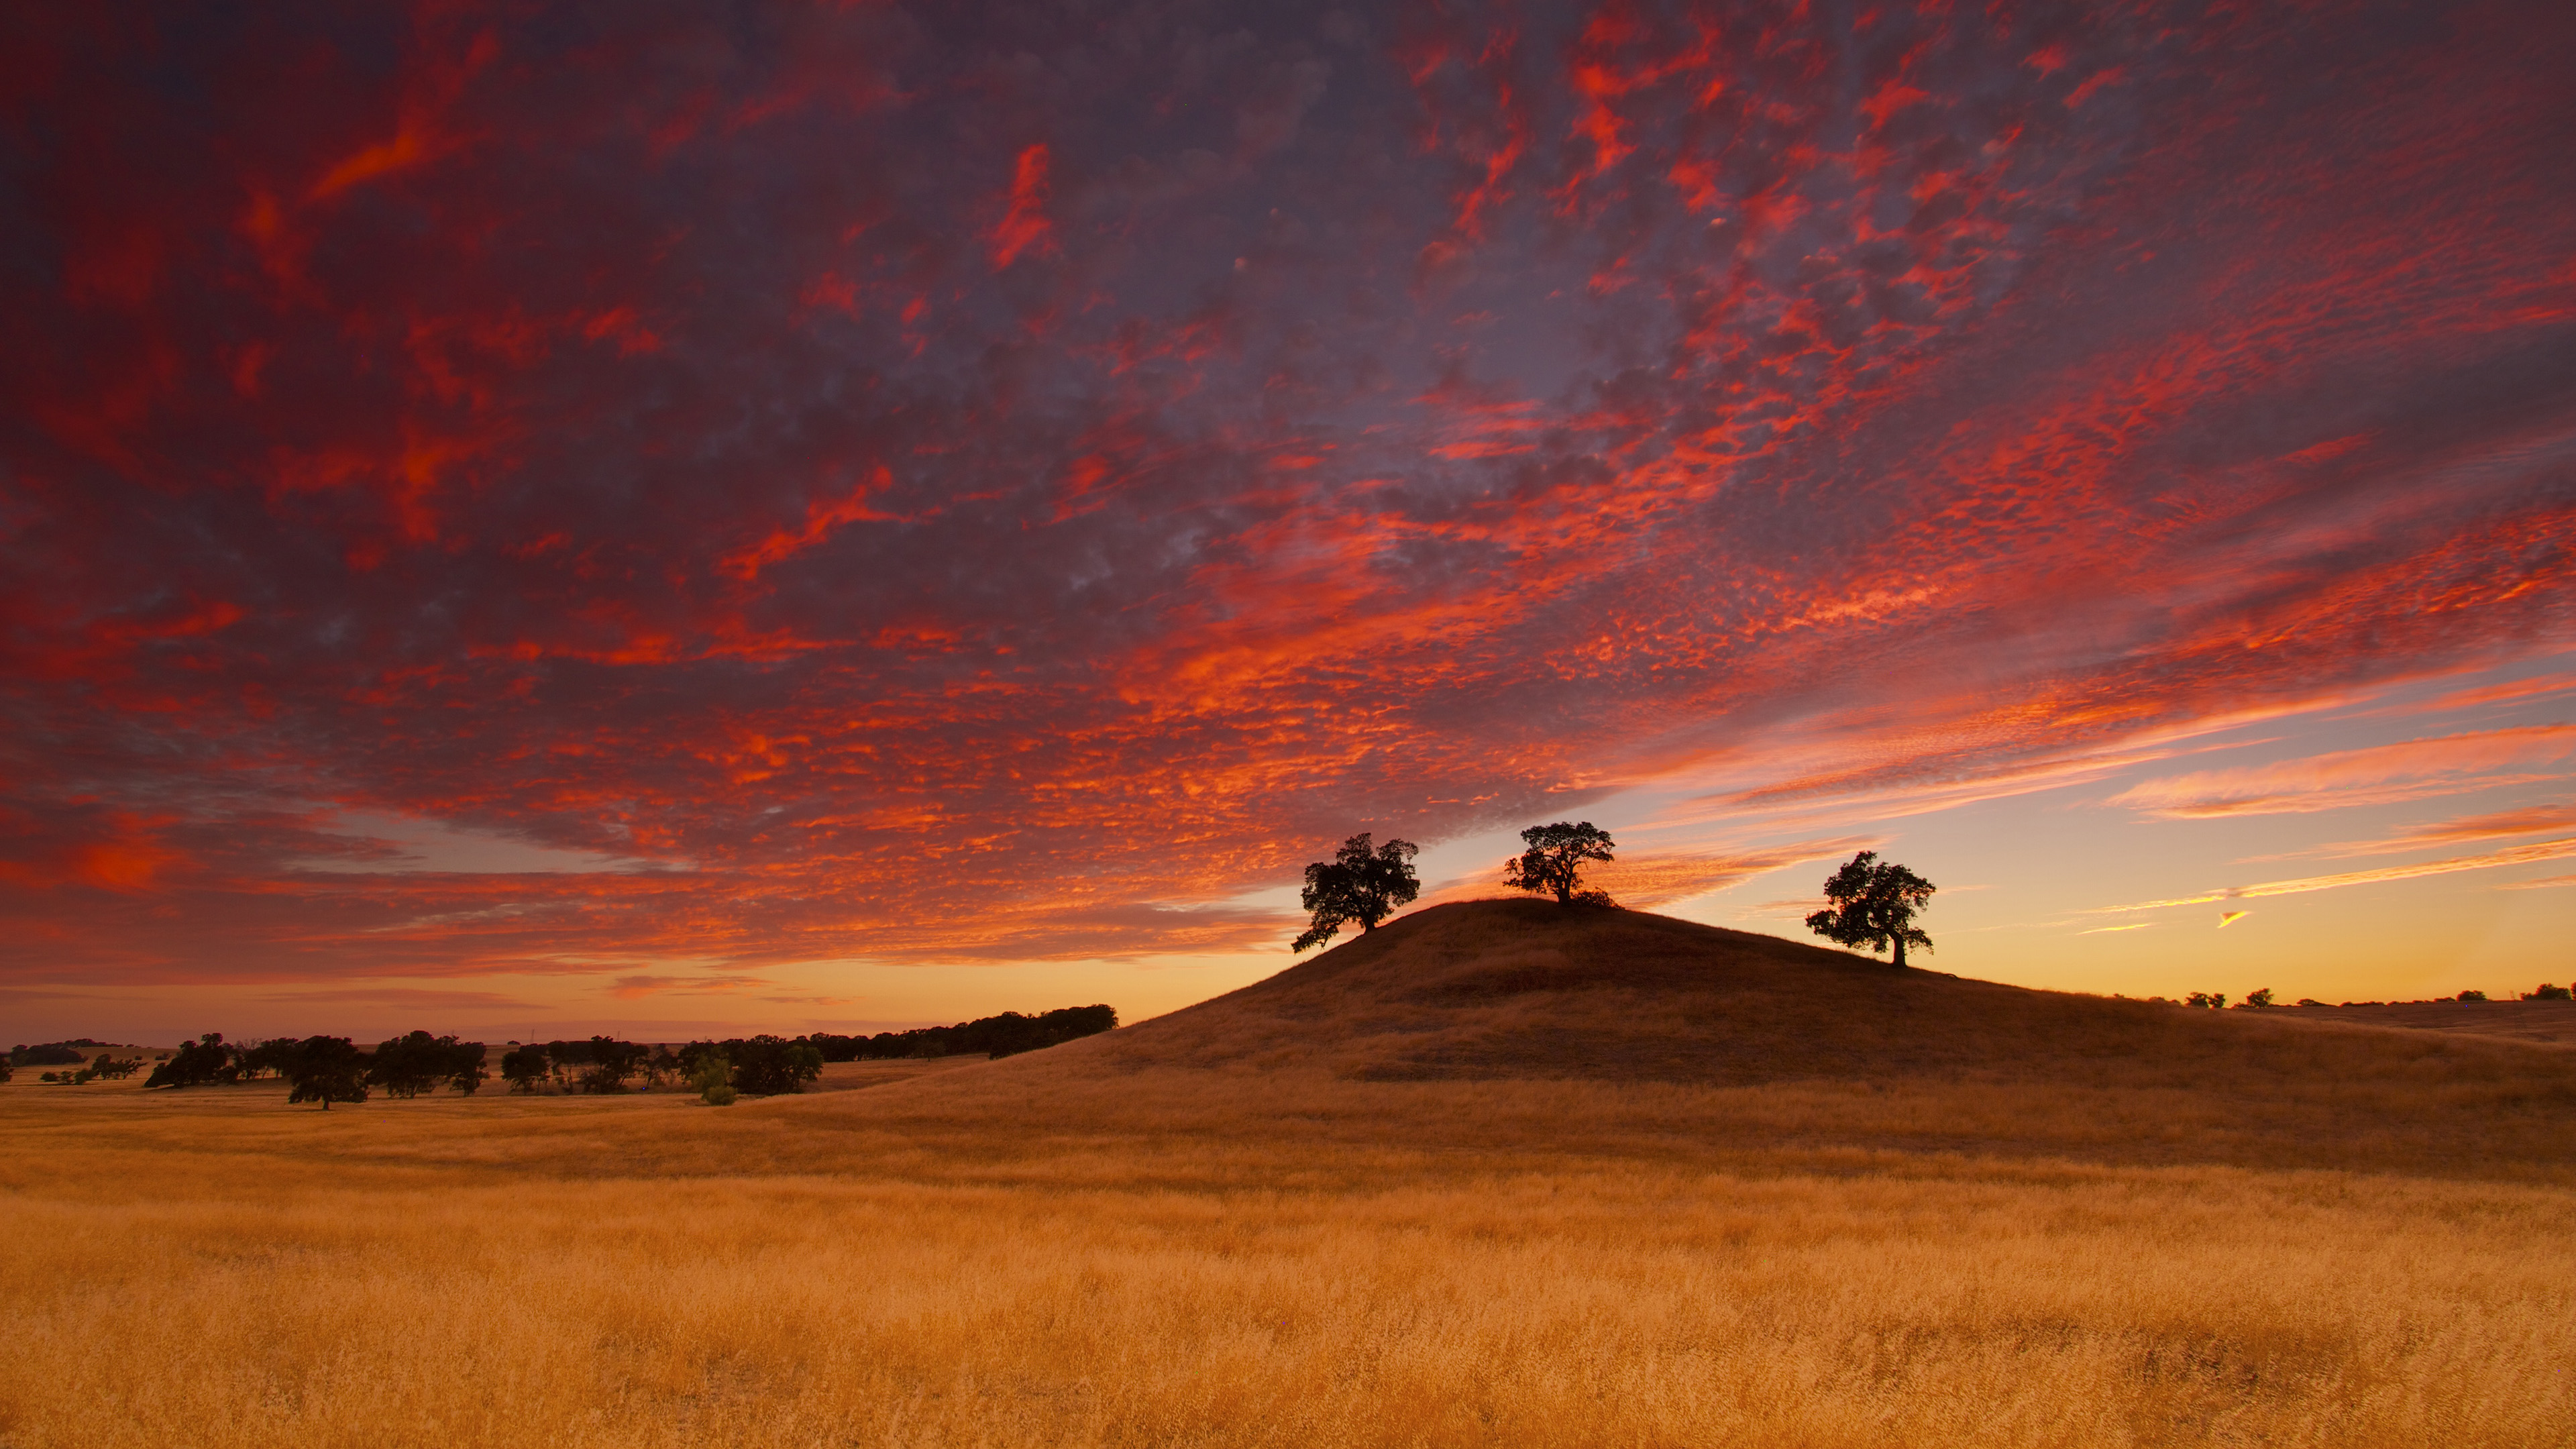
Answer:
[0, 905, 2576, 1449]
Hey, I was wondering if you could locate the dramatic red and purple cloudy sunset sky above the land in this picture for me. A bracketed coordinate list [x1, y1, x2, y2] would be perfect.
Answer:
[0, 0, 2576, 1042]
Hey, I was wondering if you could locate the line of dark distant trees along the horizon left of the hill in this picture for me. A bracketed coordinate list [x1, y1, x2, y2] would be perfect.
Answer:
[50, 1006, 1118, 1112]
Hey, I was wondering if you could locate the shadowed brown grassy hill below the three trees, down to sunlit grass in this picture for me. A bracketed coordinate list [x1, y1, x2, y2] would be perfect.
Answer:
[845, 900, 2576, 1178]
